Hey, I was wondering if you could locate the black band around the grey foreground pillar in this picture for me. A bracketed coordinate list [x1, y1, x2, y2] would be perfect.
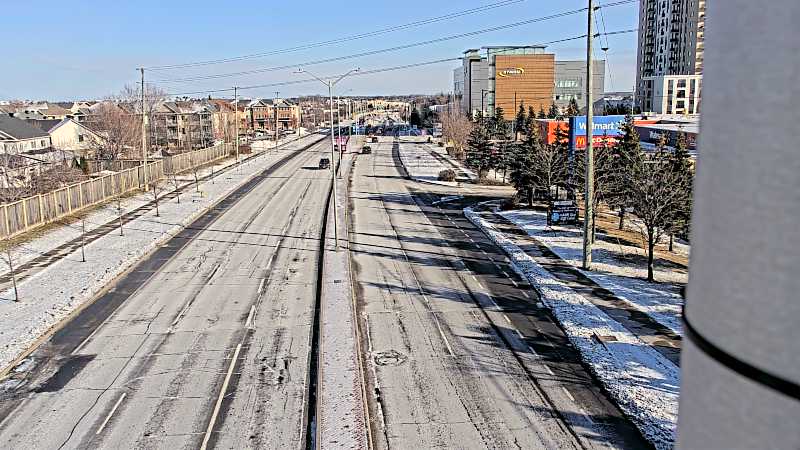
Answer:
[683, 308, 800, 400]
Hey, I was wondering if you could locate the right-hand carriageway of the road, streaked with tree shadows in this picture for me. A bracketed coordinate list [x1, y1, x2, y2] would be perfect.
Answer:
[350, 138, 649, 449]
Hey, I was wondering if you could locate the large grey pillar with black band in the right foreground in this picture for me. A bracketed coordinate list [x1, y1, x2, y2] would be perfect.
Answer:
[678, 0, 800, 449]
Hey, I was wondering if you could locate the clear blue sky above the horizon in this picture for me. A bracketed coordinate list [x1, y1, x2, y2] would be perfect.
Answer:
[0, 0, 638, 100]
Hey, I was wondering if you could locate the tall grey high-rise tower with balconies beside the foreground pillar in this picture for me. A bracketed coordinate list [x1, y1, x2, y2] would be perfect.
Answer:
[636, 0, 706, 112]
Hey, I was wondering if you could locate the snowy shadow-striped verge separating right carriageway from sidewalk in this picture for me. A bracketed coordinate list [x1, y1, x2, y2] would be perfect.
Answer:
[464, 208, 680, 449]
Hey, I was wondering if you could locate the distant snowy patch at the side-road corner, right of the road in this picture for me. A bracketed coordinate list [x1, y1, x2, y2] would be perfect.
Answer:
[400, 141, 475, 186]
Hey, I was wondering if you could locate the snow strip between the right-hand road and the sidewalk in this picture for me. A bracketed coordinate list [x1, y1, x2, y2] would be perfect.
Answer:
[464, 205, 680, 449]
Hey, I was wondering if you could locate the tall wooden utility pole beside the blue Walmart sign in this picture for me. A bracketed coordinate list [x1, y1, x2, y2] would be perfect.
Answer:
[583, 0, 594, 270]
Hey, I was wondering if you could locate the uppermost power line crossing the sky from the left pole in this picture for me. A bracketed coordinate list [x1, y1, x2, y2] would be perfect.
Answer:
[145, 0, 525, 70]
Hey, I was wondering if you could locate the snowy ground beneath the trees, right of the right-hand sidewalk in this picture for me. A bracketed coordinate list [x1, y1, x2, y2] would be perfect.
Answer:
[500, 210, 688, 334]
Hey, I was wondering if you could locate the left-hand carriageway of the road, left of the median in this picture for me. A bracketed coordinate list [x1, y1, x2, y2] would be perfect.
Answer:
[0, 140, 329, 449]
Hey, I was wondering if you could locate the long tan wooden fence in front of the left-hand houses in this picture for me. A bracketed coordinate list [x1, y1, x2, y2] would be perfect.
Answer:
[0, 144, 230, 238]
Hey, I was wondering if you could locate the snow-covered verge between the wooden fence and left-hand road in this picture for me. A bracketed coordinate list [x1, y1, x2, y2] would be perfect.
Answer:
[0, 136, 319, 368]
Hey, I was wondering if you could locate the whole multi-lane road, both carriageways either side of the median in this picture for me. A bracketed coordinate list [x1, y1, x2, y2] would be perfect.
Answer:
[0, 132, 647, 449]
